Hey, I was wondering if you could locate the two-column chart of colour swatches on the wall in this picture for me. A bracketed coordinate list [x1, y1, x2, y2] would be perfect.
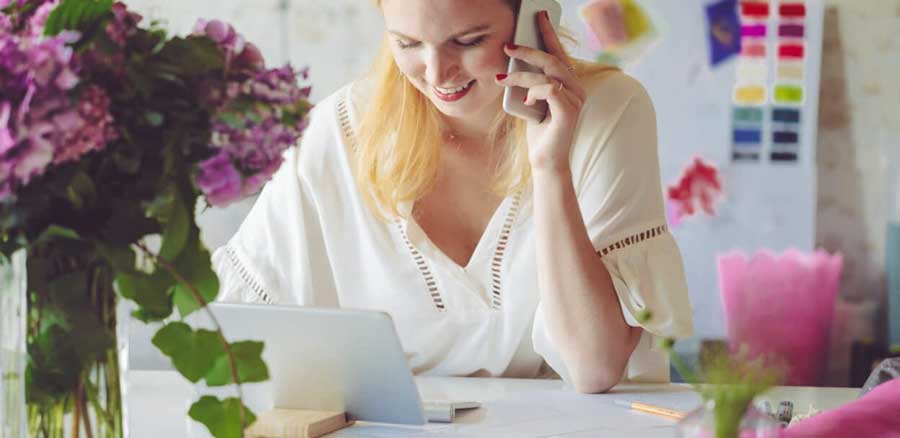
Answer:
[731, 0, 807, 163]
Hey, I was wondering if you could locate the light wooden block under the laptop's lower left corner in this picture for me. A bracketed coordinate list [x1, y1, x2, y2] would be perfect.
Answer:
[246, 409, 354, 438]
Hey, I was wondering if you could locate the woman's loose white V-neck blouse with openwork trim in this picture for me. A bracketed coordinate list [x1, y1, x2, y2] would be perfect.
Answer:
[213, 73, 692, 381]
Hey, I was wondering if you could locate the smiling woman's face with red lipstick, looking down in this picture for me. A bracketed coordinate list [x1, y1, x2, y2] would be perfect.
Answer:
[381, 0, 514, 125]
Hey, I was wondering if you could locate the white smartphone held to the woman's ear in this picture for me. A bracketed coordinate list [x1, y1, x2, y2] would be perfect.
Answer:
[503, 0, 562, 123]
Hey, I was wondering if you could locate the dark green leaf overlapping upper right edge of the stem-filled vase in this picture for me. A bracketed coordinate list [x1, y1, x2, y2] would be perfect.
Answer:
[115, 268, 175, 322]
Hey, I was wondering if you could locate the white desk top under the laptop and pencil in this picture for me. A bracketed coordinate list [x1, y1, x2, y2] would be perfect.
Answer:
[126, 371, 859, 438]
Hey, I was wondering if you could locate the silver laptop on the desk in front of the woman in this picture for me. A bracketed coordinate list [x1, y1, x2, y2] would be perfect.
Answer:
[189, 303, 480, 425]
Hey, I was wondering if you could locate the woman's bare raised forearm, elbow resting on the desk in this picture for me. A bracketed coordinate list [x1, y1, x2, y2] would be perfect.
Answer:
[533, 166, 641, 393]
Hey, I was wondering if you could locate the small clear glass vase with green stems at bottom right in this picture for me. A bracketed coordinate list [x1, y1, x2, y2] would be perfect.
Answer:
[676, 400, 781, 438]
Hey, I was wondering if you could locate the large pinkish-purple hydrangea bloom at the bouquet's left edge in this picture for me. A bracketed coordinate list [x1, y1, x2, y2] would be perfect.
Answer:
[0, 24, 116, 199]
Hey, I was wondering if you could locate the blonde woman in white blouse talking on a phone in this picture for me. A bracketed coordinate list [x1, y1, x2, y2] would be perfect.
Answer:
[214, 0, 691, 393]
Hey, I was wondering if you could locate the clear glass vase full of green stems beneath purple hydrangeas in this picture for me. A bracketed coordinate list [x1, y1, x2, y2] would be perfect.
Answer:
[25, 250, 128, 438]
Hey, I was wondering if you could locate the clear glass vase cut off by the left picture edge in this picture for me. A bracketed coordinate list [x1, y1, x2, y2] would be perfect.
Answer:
[0, 250, 26, 438]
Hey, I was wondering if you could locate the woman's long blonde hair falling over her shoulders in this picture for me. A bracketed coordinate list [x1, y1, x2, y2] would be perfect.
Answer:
[353, 0, 618, 219]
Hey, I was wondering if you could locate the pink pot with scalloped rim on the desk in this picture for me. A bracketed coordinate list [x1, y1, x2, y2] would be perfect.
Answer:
[718, 250, 843, 386]
